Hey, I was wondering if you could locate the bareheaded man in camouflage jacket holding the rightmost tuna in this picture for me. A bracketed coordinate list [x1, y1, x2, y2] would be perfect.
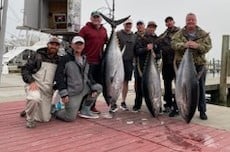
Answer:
[171, 13, 212, 120]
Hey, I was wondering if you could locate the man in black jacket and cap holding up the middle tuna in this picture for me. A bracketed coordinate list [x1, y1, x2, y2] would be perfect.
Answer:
[133, 21, 160, 112]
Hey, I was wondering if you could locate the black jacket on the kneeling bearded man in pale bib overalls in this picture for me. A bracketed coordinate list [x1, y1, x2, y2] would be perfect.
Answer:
[21, 48, 59, 84]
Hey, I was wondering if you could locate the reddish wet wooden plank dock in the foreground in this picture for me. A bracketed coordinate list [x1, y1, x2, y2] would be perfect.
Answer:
[0, 101, 230, 152]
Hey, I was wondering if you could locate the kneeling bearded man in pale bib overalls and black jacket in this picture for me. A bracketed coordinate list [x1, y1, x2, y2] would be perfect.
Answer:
[22, 37, 60, 128]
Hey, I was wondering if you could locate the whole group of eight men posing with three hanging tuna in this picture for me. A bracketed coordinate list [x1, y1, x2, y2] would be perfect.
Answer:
[22, 11, 212, 128]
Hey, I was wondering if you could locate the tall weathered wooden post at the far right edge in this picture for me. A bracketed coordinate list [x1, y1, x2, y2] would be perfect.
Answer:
[219, 35, 229, 106]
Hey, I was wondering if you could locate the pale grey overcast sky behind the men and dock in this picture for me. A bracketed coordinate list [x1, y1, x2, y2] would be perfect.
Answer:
[6, 0, 230, 59]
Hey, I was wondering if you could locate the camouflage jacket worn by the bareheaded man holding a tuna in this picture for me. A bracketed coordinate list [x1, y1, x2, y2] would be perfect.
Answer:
[171, 26, 212, 65]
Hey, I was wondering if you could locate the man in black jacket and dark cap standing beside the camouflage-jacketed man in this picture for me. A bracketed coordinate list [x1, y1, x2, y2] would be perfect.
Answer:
[158, 16, 179, 117]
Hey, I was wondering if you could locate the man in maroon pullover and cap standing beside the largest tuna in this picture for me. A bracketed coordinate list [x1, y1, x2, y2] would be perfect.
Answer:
[79, 11, 108, 114]
